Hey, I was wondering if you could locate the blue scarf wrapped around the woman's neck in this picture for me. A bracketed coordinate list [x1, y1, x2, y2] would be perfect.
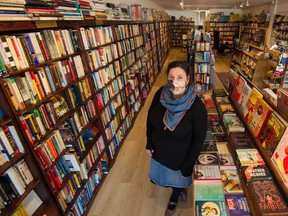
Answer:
[160, 85, 196, 131]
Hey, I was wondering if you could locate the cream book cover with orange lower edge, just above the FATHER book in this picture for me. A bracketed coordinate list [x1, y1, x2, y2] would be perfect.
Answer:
[236, 148, 265, 167]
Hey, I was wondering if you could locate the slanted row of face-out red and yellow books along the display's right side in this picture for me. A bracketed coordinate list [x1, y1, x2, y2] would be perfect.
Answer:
[229, 72, 288, 191]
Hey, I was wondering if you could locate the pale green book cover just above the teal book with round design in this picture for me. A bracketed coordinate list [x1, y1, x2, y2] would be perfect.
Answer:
[193, 180, 225, 201]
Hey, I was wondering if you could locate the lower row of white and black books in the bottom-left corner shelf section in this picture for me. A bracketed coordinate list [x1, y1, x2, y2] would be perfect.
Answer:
[0, 159, 34, 209]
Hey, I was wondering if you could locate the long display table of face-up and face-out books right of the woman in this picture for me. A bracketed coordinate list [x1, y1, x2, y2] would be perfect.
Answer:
[193, 88, 288, 215]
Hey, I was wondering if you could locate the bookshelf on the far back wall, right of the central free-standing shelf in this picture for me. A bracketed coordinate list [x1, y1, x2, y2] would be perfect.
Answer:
[206, 21, 239, 50]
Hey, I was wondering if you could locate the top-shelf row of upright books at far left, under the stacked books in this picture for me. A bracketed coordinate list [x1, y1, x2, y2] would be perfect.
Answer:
[0, 29, 82, 75]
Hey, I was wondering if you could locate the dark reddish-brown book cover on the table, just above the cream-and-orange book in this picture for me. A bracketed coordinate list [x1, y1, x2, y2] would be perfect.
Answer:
[228, 132, 253, 149]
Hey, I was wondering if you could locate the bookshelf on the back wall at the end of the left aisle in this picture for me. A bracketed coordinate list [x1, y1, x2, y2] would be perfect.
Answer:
[172, 20, 194, 47]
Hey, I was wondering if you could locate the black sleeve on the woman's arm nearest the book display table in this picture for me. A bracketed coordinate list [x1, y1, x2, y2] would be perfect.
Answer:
[181, 96, 208, 177]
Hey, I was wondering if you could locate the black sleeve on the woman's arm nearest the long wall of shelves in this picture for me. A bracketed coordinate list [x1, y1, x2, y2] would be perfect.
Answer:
[146, 87, 163, 150]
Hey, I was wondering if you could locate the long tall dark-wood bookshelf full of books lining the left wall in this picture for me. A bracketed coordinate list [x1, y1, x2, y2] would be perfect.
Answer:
[0, 20, 169, 215]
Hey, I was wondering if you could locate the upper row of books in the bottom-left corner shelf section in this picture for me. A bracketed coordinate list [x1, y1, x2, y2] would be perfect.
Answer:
[0, 125, 25, 163]
